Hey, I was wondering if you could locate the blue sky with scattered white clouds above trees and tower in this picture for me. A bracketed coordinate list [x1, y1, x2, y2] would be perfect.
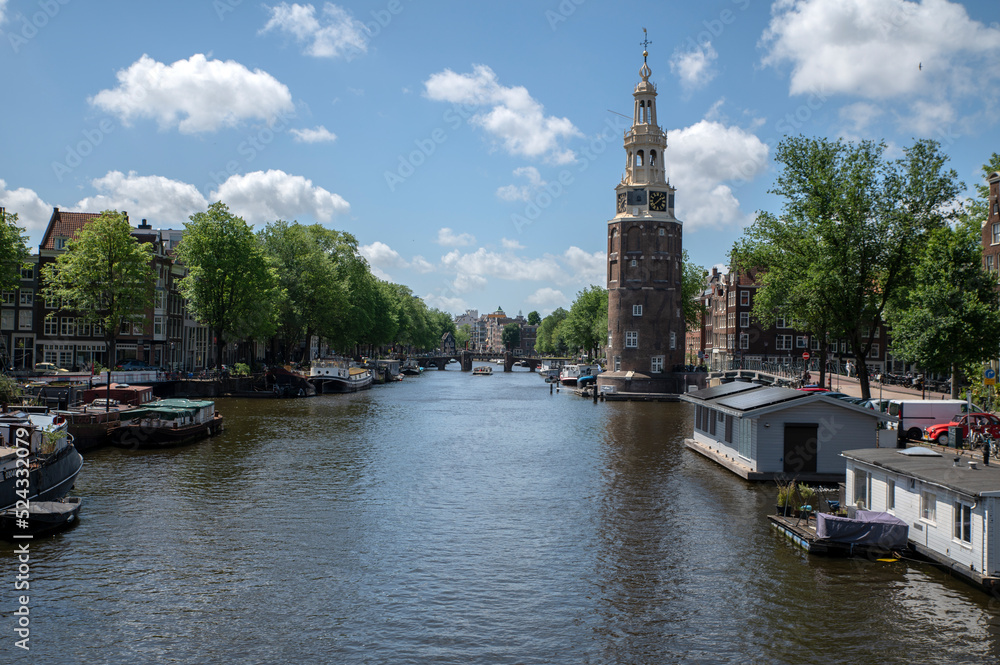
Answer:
[0, 0, 1000, 314]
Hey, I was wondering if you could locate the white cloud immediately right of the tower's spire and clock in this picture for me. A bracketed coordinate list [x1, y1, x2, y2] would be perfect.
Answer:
[667, 120, 769, 229]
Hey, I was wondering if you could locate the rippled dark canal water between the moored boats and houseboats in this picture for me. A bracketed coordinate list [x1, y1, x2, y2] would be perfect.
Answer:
[0, 365, 1000, 665]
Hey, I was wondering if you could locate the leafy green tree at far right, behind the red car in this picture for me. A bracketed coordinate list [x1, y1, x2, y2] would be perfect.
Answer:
[888, 220, 1000, 398]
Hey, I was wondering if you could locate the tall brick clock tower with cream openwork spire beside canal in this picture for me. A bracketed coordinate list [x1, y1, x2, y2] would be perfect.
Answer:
[598, 36, 685, 393]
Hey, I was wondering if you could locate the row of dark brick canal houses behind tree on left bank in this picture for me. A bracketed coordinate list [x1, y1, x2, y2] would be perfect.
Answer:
[0, 208, 225, 371]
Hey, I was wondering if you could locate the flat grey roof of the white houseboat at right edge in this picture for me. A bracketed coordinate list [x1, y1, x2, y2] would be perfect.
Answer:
[841, 446, 1000, 497]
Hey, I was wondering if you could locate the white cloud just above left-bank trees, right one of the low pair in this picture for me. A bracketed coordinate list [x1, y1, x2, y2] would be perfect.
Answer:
[212, 169, 351, 224]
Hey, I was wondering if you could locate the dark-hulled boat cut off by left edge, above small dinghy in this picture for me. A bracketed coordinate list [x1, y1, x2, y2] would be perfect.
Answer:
[0, 409, 83, 510]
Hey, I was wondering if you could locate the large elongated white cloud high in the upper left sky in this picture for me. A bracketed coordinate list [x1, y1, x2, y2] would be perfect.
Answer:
[90, 53, 293, 134]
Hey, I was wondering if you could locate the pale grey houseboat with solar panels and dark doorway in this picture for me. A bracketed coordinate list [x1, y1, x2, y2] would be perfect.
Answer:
[681, 381, 895, 482]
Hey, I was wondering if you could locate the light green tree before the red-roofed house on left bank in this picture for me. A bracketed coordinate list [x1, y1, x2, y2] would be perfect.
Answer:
[41, 210, 156, 378]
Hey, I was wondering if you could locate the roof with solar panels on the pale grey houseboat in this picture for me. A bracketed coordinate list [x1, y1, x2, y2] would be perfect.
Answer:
[681, 381, 897, 421]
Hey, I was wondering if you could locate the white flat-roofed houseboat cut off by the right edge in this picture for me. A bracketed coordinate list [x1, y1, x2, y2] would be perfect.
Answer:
[843, 446, 1000, 591]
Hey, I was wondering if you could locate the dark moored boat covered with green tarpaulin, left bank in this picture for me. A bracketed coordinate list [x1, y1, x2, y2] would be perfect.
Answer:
[111, 398, 223, 449]
